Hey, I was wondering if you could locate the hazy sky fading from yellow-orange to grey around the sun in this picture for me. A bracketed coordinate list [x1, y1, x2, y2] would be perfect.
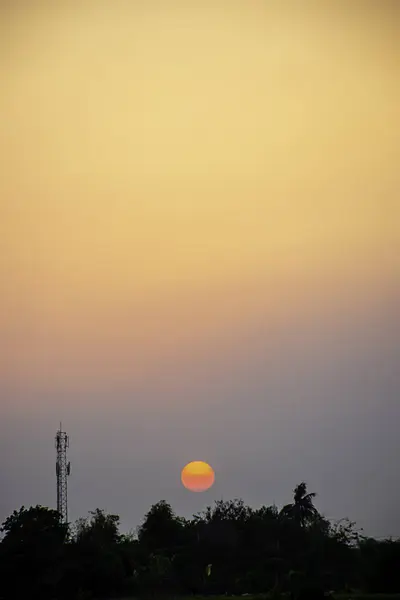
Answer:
[0, 0, 400, 537]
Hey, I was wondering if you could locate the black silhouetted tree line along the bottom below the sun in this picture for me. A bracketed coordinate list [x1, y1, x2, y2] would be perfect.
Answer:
[0, 483, 400, 600]
